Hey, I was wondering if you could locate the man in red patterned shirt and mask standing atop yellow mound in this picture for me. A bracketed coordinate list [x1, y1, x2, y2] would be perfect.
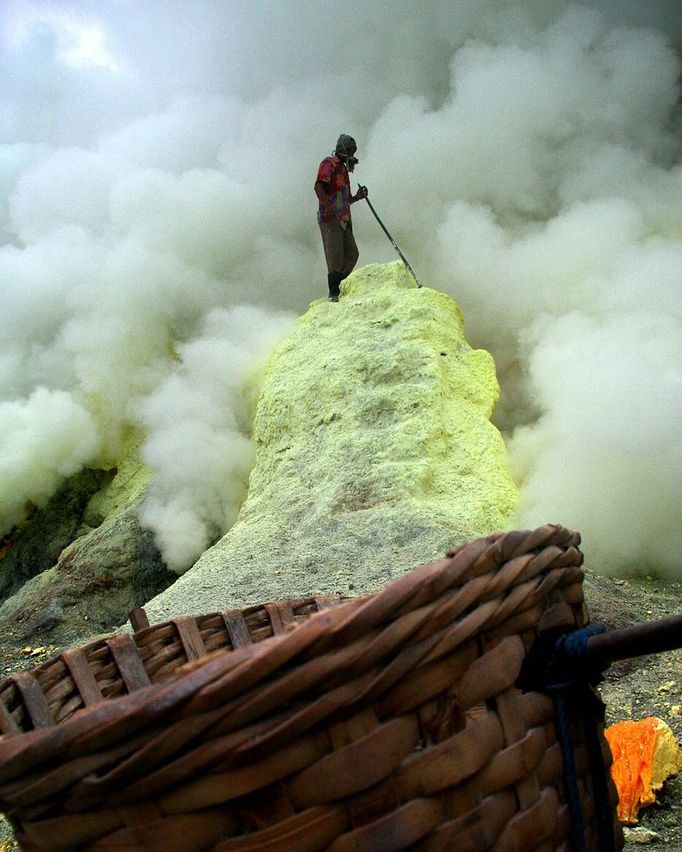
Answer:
[315, 133, 367, 302]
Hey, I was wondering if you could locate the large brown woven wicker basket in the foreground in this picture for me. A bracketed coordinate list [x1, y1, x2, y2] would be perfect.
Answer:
[0, 526, 622, 852]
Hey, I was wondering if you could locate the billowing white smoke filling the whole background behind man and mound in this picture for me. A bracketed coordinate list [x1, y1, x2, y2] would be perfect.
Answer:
[0, 0, 682, 575]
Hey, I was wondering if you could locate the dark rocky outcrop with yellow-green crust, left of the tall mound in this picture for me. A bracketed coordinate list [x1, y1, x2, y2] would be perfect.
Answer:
[0, 435, 176, 644]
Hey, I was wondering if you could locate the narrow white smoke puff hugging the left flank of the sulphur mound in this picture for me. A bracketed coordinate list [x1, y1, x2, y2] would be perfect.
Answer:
[139, 307, 291, 572]
